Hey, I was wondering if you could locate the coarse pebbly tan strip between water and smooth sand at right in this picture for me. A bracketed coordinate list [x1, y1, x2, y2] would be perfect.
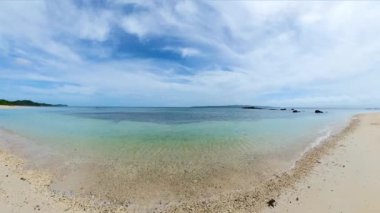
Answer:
[165, 113, 360, 212]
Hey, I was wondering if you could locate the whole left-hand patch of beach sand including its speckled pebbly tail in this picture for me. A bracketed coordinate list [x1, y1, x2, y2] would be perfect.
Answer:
[0, 149, 131, 213]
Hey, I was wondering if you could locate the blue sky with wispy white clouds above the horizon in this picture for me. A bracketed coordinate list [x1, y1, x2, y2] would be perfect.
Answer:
[0, 0, 380, 107]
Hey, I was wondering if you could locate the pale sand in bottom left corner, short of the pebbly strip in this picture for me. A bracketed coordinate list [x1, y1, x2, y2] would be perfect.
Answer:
[0, 151, 78, 212]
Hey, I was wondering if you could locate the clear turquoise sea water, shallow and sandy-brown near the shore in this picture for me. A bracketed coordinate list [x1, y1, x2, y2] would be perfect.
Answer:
[0, 107, 359, 207]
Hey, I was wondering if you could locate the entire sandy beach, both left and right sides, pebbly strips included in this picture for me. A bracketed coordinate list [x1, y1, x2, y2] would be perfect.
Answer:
[0, 113, 380, 212]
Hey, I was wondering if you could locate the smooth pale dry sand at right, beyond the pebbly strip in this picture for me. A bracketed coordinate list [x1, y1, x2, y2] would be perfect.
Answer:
[263, 113, 380, 213]
